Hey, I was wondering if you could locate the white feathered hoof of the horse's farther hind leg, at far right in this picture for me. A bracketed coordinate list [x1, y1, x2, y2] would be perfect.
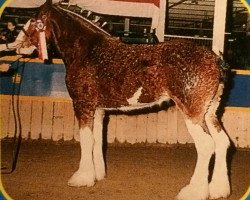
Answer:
[209, 180, 230, 199]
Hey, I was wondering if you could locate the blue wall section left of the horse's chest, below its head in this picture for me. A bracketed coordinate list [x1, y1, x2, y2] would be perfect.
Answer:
[0, 61, 69, 98]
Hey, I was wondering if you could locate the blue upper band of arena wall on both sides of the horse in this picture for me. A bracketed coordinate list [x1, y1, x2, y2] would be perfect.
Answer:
[0, 58, 250, 107]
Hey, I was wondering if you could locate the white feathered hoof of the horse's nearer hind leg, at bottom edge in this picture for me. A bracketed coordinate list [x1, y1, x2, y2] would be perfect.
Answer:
[176, 184, 208, 200]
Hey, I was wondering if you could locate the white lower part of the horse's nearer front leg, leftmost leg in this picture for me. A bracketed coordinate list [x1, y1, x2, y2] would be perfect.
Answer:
[68, 127, 95, 187]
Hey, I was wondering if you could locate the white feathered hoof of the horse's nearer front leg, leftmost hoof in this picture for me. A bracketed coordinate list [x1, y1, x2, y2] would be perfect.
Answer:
[68, 170, 95, 187]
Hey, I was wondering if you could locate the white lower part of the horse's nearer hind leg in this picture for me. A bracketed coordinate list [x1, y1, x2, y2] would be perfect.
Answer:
[177, 119, 215, 200]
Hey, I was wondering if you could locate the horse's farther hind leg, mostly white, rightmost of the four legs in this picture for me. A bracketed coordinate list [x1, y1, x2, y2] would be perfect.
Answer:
[205, 84, 230, 199]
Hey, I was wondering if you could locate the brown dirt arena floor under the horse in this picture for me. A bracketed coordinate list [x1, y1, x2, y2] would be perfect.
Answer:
[2, 140, 250, 200]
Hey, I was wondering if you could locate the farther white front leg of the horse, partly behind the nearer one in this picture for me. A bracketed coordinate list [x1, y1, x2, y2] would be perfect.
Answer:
[93, 109, 106, 180]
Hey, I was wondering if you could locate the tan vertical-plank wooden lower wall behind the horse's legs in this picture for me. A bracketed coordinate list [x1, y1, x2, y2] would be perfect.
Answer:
[0, 95, 250, 148]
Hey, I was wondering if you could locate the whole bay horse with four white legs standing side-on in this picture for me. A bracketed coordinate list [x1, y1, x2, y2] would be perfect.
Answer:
[23, 1, 230, 200]
